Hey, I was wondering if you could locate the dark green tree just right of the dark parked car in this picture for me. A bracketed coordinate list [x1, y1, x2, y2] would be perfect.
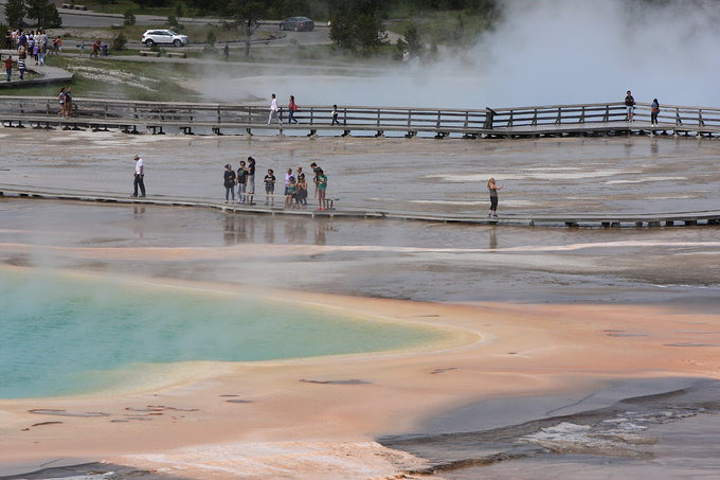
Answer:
[330, 0, 387, 55]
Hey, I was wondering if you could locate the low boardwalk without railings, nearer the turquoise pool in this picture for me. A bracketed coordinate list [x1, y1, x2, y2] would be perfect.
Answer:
[0, 186, 720, 228]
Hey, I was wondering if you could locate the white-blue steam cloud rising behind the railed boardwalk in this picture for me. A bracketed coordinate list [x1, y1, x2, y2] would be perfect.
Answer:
[218, 0, 720, 108]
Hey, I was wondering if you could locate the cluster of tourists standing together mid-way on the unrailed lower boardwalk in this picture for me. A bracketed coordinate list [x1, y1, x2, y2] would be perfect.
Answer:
[223, 157, 327, 210]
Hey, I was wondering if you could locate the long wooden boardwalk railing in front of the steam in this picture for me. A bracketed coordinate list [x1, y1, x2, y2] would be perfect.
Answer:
[0, 96, 720, 138]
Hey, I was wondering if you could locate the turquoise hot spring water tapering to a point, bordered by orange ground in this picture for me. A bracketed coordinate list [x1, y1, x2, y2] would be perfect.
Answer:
[0, 270, 450, 398]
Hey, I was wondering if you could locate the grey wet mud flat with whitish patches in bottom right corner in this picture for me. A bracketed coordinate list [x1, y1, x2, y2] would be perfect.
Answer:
[379, 378, 720, 480]
